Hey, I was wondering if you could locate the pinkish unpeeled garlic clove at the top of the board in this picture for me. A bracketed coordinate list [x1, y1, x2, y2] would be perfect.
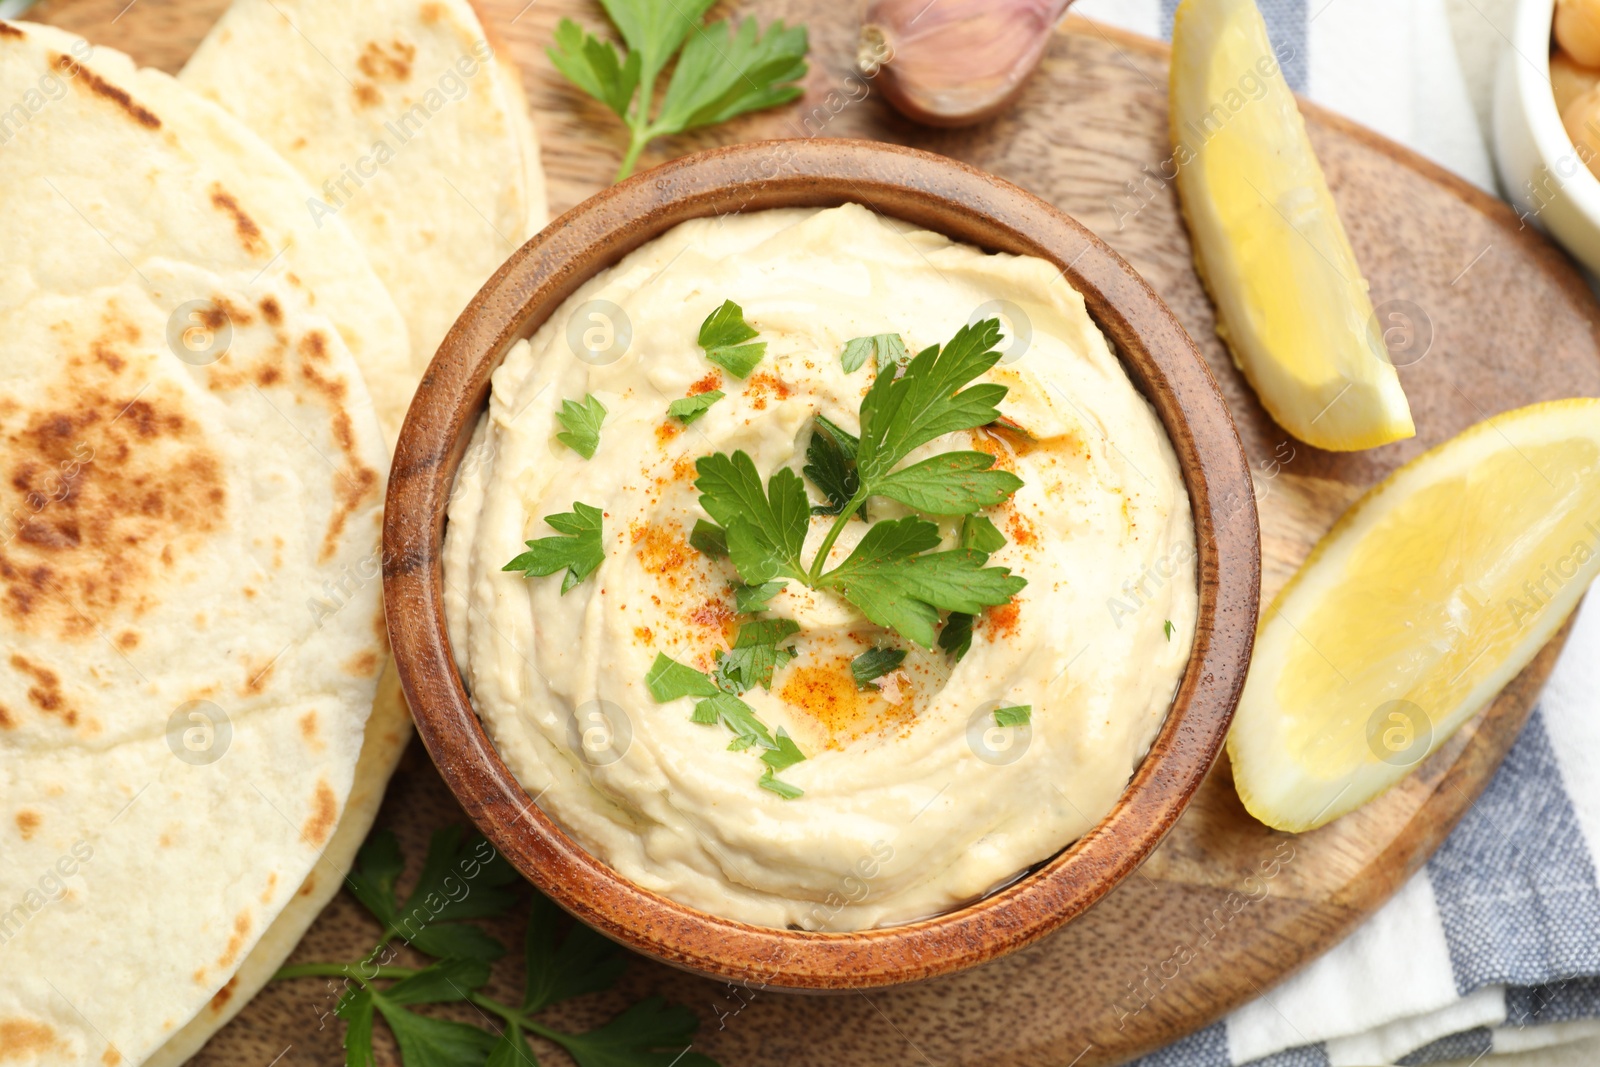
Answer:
[856, 0, 1072, 126]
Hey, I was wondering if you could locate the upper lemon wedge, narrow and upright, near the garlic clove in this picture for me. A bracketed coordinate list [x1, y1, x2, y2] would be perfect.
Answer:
[1168, 0, 1416, 451]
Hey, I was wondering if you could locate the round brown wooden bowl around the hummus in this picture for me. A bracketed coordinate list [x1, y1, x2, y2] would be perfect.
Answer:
[384, 139, 1261, 990]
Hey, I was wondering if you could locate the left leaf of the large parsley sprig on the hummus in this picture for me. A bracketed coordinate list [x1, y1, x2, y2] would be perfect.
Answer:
[694, 451, 811, 585]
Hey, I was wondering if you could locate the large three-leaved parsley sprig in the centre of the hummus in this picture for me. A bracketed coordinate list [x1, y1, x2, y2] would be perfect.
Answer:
[694, 318, 1027, 648]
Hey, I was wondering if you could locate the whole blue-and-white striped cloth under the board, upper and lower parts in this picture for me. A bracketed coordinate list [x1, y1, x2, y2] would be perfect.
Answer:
[1074, 0, 1600, 1067]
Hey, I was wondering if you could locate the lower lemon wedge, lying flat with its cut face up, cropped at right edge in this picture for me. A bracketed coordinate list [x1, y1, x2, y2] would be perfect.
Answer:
[1227, 400, 1600, 832]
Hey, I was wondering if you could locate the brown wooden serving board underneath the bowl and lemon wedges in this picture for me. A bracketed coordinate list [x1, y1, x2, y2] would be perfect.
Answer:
[35, 0, 1600, 1067]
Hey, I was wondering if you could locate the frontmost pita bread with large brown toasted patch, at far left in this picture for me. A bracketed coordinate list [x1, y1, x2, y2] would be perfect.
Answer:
[0, 24, 386, 1067]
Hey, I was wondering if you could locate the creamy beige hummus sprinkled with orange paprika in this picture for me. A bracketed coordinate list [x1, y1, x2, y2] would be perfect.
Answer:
[445, 205, 1197, 931]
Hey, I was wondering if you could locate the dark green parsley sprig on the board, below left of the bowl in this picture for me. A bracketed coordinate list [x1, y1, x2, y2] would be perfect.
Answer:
[274, 827, 717, 1067]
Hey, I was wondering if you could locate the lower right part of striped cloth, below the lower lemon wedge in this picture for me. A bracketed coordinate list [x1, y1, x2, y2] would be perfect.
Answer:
[1139, 597, 1600, 1067]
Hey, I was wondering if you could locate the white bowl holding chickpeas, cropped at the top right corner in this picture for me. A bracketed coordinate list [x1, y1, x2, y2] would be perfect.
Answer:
[1494, 0, 1600, 272]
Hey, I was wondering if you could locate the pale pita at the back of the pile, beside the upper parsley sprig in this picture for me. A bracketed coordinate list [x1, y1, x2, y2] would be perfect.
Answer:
[179, 0, 546, 379]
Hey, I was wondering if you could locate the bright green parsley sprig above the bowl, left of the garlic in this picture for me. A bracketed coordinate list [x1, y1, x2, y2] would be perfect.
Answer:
[547, 0, 808, 181]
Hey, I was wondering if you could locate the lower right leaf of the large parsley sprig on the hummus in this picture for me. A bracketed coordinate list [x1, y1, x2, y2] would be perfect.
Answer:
[821, 517, 1027, 648]
